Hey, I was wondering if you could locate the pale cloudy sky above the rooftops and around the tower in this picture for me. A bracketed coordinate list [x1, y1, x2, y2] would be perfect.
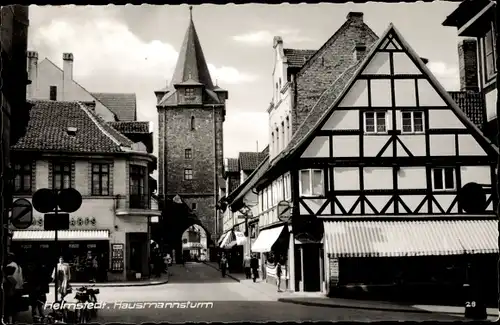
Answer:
[28, 1, 459, 161]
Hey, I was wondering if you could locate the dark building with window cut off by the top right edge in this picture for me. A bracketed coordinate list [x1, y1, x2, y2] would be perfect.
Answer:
[443, 0, 498, 144]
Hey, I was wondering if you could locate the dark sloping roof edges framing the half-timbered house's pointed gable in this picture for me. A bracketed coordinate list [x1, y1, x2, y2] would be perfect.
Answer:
[284, 23, 498, 165]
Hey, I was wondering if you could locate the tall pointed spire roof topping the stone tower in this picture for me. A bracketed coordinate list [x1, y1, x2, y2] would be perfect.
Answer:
[171, 6, 214, 89]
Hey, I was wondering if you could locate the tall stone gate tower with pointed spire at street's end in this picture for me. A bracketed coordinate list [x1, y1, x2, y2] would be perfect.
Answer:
[155, 7, 228, 240]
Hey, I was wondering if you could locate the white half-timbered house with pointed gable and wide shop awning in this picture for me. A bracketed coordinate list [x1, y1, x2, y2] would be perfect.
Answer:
[256, 24, 498, 291]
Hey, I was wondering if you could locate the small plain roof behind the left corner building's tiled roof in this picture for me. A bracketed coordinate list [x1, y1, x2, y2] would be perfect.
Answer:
[90, 93, 137, 121]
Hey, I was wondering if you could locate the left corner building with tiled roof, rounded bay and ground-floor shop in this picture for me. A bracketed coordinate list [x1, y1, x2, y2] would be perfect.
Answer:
[11, 100, 161, 281]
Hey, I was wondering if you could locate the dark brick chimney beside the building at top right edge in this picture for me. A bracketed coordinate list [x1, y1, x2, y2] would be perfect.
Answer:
[458, 39, 479, 91]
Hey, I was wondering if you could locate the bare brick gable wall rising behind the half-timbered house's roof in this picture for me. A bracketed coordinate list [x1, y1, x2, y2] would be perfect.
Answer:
[292, 13, 378, 132]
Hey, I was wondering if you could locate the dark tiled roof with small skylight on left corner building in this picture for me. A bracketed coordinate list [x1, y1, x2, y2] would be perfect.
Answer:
[12, 100, 133, 153]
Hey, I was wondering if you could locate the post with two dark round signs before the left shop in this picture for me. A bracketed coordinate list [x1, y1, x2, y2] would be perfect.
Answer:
[32, 188, 82, 302]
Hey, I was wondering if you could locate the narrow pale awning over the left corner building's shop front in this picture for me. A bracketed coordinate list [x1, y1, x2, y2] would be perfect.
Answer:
[12, 230, 109, 241]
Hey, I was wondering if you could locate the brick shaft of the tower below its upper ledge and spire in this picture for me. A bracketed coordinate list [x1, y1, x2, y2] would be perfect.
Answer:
[158, 107, 224, 237]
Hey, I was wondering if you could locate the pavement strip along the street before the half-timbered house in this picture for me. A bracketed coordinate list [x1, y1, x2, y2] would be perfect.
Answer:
[278, 296, 498, 317]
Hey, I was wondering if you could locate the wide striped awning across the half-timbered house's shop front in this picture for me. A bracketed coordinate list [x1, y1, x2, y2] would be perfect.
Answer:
[324, 220, 498, 258]
